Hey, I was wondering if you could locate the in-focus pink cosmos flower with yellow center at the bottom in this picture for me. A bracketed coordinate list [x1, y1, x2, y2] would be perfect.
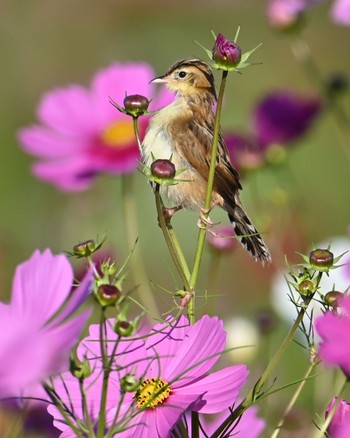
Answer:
[48, 316, 248, 438]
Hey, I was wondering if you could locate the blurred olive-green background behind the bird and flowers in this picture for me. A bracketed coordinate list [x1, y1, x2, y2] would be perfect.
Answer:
[0, 0, 350, 436]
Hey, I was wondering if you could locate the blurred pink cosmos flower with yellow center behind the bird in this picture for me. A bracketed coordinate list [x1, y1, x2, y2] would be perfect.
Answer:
[18, 63, 171, 191]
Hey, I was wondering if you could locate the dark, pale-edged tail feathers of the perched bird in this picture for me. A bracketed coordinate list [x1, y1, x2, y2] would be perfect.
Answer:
[227, 202, 271, 265]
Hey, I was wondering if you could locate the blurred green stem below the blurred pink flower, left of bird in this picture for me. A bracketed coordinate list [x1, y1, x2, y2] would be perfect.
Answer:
[122, 175, 160, 319]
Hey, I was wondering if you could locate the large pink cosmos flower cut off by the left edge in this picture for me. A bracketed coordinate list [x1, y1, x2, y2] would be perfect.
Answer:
[0, 249, 91, 398]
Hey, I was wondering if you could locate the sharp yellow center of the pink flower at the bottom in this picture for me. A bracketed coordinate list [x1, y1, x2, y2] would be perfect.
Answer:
[134, 378, 171, 409]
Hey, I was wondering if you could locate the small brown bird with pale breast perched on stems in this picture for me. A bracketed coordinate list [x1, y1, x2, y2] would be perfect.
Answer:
[142, 58, 271, 264]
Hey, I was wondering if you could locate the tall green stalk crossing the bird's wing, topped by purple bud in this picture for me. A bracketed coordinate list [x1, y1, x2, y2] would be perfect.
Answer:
[190, 70, 228, 289]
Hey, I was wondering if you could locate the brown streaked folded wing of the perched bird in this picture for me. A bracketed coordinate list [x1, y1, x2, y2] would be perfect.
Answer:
[172, 114, 242, 203]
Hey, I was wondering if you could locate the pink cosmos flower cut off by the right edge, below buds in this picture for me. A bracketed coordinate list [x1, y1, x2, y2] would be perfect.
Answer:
[315, 296, 350, 376]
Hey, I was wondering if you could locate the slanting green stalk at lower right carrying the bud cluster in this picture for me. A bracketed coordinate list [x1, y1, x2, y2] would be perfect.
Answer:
[211, 290, 316, 438]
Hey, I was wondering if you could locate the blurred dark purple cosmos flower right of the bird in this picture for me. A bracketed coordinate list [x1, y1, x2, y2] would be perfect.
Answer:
[253, 91, 321, 148]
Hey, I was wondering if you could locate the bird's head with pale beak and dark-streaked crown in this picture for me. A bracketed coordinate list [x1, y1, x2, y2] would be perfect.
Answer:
[151, 58, 216, 98]
